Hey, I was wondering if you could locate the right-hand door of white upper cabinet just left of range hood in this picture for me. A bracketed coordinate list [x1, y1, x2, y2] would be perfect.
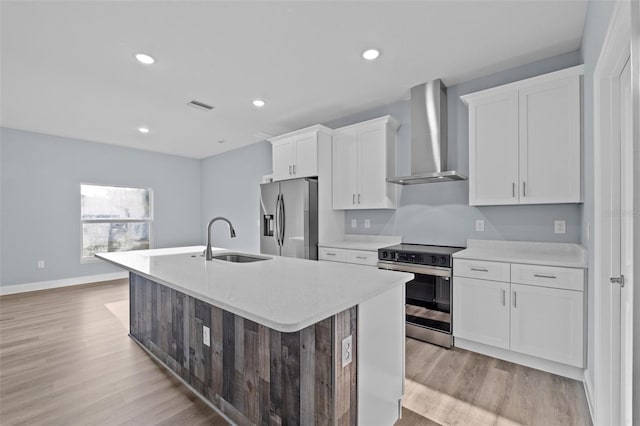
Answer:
[356, 123, 390, 209]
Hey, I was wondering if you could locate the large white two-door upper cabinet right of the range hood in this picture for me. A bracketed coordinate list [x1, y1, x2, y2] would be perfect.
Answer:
[462, 65, 584, 206]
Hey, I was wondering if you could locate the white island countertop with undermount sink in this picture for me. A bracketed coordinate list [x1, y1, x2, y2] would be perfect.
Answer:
[96, 246, 413, 332]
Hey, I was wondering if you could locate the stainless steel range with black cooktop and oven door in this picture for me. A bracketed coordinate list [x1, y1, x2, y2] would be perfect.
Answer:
[378, 244, 464, 348]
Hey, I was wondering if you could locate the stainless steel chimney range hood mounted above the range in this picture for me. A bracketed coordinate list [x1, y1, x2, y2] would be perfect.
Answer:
[387, 79, 467, 185]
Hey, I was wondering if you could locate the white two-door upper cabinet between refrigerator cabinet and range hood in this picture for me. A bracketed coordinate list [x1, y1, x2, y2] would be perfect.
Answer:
[332, 116, 399, 210]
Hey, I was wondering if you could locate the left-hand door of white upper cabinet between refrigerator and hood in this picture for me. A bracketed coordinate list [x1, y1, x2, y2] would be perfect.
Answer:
[332, 128, 358, 209]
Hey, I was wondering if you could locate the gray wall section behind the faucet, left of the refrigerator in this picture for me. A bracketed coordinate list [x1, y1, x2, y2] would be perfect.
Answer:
[201, 141, 272, 253]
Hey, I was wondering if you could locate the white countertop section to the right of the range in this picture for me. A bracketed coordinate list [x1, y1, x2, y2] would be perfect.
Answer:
[453, 240, 587, 268]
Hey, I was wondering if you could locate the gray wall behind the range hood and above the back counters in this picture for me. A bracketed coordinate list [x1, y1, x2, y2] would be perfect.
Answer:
[325, 51, 581, 245]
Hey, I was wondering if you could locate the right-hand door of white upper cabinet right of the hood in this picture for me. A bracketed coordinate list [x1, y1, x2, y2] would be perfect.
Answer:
[520, 77, 582, 204]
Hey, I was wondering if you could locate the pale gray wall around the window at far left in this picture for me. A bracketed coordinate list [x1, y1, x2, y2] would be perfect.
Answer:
[0, 128, 201, 286]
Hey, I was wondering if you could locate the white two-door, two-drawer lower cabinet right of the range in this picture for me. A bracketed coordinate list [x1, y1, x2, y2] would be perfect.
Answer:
[453, 259, 585, 368]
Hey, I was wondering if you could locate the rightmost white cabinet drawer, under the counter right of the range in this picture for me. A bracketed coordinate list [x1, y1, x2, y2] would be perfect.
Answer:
[511, 263, 584, 291]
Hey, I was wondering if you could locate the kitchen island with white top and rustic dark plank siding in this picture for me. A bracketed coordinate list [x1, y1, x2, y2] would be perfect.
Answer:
[96, 247, 411, 425]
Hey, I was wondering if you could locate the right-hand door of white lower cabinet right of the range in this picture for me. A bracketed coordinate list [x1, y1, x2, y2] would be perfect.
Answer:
[511, 284, 584, 368]
